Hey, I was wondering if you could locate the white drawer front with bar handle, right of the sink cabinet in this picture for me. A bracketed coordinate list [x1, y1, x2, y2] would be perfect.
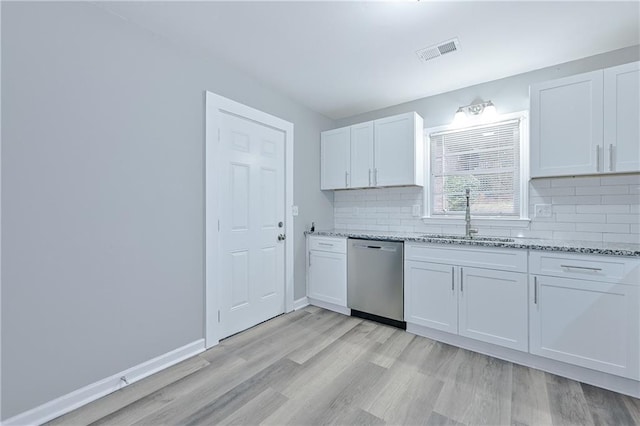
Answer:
[530, 251, 640, 285]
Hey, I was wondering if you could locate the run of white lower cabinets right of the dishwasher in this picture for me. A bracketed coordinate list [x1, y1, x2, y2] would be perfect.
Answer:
[404, 242, 640, 398]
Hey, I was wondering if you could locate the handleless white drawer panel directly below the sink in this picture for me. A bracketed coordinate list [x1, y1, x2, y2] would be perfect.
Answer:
[405, 244, 527, 272]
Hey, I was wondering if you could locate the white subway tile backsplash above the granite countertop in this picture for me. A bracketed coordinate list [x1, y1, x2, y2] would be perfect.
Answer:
[334, 174, 640, 243]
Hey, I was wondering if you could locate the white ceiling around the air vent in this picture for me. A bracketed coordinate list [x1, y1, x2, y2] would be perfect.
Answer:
[99, 0, 640, 119]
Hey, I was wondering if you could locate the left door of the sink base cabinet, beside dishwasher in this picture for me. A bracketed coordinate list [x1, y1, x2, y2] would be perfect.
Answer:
[404, 261, 458, 334]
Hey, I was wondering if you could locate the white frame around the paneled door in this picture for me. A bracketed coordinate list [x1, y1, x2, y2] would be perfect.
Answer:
[204, 91, 294, 348]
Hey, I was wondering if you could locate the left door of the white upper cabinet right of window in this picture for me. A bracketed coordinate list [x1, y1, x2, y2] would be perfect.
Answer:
[529, 70, 603, 177]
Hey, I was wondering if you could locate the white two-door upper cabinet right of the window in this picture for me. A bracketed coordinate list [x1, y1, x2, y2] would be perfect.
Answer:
[530, 62, 640, 177]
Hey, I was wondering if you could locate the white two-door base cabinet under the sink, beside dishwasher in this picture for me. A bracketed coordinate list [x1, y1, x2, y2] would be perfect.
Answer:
[405, 244, 528, 351]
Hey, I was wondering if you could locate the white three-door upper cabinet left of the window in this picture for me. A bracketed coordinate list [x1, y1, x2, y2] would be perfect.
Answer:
[320, 112, 424, 190]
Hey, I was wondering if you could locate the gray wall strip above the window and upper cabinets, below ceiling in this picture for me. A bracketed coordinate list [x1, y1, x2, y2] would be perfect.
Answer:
[338, 45, 640, 128]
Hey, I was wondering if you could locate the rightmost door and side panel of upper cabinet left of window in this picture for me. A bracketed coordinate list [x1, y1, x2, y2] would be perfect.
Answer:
[373, 112, 424, 186]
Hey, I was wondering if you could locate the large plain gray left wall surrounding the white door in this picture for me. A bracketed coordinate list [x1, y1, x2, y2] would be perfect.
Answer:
[1, 2, 335, 419]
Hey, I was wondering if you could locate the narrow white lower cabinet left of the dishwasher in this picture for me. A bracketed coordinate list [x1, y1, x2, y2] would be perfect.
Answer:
[307, 236, 347, 308]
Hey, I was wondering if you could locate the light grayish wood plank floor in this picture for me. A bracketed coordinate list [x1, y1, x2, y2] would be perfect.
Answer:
[50, 306, 640, 425]
